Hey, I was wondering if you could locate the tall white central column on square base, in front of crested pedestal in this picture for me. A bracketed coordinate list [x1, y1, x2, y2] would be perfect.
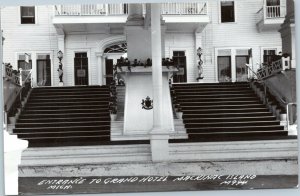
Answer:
[150, 3, 169, 161]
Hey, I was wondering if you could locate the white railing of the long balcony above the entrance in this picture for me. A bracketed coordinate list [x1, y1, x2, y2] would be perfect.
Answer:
[55, 2, 207, 16]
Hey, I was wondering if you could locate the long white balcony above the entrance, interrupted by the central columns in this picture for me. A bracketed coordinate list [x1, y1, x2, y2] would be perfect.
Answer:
[53, 2, 209, 31]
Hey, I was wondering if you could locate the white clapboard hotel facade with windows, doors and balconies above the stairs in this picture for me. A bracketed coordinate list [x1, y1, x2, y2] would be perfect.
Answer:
[1, 0, 286, 86]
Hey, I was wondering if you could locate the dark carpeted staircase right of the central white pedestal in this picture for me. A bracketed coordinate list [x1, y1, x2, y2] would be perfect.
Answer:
[170, 83, 296, 142]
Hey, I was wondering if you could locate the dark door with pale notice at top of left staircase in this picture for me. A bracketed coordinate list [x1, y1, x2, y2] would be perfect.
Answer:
[74, 52, 89, 85]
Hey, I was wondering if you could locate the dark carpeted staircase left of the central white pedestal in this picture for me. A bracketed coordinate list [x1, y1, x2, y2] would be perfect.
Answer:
[13, 86, 110, 146]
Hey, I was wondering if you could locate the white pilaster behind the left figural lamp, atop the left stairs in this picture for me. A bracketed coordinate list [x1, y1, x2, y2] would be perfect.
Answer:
[54, 35, 67, 86]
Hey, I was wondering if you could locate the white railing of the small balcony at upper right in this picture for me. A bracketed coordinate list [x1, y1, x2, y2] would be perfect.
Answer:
[257, 6, 286, 22]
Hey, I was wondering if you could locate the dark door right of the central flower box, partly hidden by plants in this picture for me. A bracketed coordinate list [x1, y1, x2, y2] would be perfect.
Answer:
[173, 51, 187, 83]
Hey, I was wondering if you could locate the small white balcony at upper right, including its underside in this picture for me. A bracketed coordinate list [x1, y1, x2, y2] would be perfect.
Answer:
[256, 6, 286, 32]
